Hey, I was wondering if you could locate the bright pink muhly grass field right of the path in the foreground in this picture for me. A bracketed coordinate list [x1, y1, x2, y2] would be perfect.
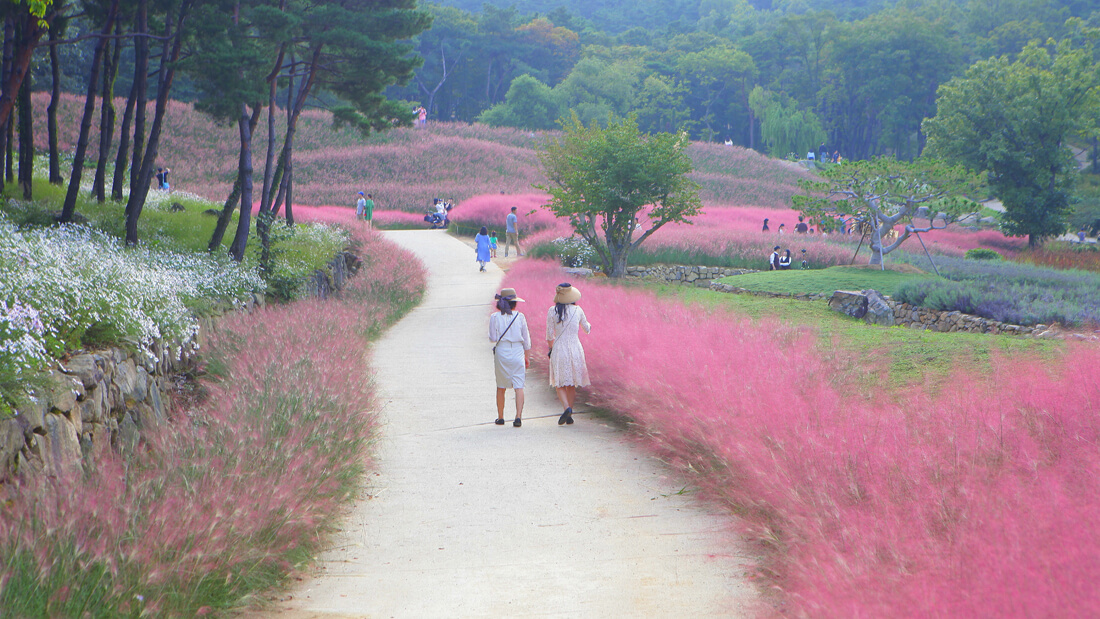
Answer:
[505, 262, 1100, 618]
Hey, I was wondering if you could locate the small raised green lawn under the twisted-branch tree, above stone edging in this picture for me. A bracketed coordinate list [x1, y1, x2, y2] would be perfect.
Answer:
[719, 266, 931, 295]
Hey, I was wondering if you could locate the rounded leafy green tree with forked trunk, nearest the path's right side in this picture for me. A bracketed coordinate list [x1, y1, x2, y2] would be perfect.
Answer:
[539, 114, 702, 277]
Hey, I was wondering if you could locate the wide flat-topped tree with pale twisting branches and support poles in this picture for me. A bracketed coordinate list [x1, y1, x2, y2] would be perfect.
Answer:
[793, 157, 981, 264]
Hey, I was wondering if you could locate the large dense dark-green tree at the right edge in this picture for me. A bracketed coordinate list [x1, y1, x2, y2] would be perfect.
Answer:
[924, 33, 1100, 247]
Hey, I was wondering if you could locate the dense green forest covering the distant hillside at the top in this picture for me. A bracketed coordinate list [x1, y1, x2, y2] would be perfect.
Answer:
[388, 0, 1100, 158]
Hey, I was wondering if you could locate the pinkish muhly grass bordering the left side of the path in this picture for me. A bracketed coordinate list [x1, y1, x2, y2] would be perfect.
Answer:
[0, 217, 425, 617]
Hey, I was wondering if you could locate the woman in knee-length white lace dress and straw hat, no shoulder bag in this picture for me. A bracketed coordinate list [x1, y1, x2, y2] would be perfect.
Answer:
[547, 284, 592, 425]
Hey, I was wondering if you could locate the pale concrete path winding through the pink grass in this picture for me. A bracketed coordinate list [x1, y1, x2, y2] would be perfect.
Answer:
[275, 231, 757, 619]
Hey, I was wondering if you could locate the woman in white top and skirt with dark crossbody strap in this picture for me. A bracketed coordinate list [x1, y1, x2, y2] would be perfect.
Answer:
[488, 288, 531, 428]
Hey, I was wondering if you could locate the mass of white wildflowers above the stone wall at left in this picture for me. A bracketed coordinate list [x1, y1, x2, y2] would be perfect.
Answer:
[0, 217, 264, 365]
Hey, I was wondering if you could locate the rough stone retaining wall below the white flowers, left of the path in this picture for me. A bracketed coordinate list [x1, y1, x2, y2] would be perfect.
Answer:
[0, 252, 361, 482]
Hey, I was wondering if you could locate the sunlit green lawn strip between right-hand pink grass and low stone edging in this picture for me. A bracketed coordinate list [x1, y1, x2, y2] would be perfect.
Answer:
[646, 281, 1063, 391]
